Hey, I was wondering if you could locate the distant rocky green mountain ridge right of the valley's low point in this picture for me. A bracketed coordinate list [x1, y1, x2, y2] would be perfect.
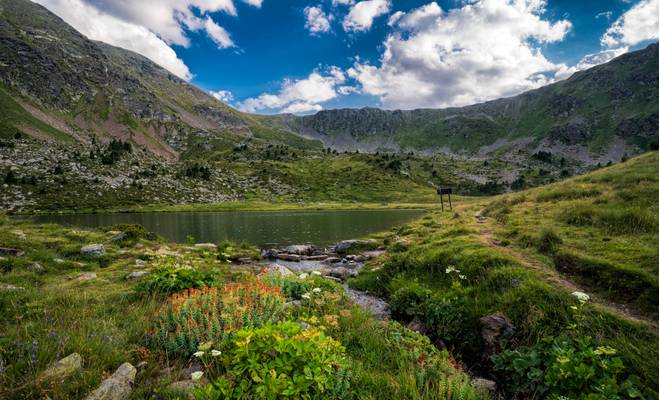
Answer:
[273, 44, 659, 163]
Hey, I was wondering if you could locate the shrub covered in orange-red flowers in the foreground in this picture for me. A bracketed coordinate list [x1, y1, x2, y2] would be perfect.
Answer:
[151, 278, 285, 355]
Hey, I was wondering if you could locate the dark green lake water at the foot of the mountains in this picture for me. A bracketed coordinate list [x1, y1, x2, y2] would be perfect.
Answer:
[34, 210, 424, 247]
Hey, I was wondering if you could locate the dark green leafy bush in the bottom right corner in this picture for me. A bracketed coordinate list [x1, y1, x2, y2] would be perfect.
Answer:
[491, 337, 642, 400]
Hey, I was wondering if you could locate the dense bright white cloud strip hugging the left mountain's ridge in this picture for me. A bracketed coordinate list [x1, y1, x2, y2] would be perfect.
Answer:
[37, 0, 192, 80]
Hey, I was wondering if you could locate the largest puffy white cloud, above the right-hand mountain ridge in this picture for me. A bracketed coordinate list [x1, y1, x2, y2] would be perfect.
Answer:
[348, 0, 571, 108]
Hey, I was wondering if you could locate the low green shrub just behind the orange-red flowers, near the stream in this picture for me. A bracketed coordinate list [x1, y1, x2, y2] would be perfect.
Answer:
[135, 262, 215, 295]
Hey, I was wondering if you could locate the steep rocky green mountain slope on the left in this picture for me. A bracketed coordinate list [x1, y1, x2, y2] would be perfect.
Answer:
[0, 0, 320, 159]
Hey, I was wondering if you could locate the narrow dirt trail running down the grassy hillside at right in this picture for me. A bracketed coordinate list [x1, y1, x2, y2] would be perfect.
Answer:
[475, 212, 659, 334]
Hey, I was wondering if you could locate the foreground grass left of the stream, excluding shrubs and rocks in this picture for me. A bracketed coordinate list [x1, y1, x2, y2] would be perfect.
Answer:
[0, 216, 480, 400]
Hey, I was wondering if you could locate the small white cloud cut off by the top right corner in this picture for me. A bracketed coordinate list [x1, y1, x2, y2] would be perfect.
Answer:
[601, 0, 659, 47]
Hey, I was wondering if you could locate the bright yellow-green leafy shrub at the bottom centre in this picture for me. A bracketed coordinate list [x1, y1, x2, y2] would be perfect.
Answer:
[196, 322, 350, 399]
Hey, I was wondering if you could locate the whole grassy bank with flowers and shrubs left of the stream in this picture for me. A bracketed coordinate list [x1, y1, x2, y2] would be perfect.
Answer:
[0, 217, 484, 399]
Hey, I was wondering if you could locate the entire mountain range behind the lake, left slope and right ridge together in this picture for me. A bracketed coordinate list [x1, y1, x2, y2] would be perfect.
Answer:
[0, 0, 659, 165]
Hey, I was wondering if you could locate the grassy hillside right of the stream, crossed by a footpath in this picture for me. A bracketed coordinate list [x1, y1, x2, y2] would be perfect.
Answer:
[351, 152, 659, 399]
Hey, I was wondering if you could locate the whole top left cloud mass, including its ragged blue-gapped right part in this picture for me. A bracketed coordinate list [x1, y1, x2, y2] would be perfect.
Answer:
[34, 0, 263, 80]
